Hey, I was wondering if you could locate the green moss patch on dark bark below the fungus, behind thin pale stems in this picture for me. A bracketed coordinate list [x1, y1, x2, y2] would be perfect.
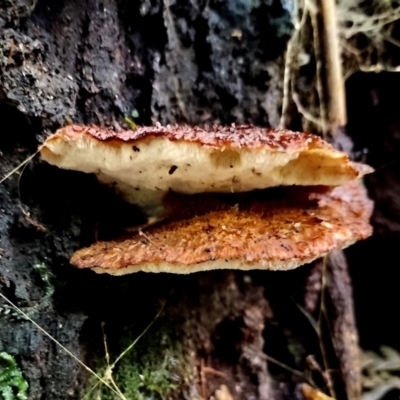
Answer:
[85, 321, 188, 400]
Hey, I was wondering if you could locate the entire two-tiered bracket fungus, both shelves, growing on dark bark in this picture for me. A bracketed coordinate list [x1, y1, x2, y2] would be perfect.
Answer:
[41, 125, 372, 275]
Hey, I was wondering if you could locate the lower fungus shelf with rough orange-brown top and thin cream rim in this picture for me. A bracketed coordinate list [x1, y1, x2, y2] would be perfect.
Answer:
[71, 181, 372, 275]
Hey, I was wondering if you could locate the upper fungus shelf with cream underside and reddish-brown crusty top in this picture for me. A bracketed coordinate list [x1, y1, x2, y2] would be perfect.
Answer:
[41, 125, 368, 216]
